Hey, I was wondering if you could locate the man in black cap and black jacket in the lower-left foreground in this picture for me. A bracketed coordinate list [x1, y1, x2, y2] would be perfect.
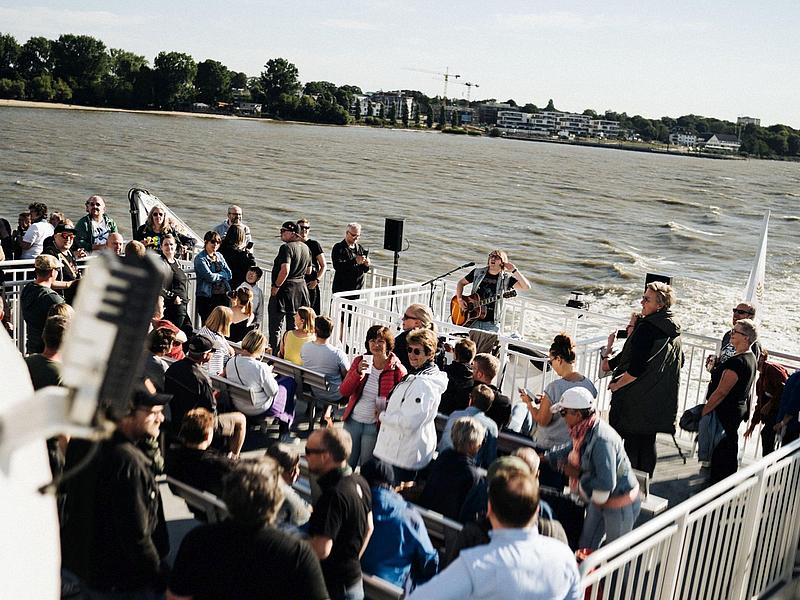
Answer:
[61, 388, 170, 598]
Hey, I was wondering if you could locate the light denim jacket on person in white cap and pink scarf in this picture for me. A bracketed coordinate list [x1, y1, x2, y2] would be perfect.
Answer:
[545, 419, 637, 498]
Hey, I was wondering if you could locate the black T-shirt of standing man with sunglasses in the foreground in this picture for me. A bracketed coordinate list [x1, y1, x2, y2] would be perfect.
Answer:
[308, 469, 372, 594]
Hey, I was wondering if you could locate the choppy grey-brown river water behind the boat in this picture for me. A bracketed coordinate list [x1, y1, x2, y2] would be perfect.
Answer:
[0, 107, 800, 352]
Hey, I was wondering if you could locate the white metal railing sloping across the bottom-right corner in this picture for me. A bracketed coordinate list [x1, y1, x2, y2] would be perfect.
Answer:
[581, 440, 800, 600]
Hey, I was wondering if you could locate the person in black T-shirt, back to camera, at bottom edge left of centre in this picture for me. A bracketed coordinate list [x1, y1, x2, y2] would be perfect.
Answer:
[167, 457, 328, 600]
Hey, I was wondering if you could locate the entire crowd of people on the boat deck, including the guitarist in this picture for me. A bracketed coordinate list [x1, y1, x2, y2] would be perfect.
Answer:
[0, 196, 800, 600]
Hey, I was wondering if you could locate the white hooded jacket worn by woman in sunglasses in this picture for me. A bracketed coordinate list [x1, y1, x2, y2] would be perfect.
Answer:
[373, 365, 447, 470]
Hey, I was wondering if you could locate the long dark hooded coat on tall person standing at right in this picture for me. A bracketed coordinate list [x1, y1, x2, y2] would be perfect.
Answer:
[608, 309, 683, 437]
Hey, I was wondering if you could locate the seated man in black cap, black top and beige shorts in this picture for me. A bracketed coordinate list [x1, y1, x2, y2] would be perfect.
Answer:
[164, 335, 247, 457]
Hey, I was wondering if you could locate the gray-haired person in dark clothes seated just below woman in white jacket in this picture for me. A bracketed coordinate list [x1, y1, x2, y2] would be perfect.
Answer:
[419, 417, 486, 521]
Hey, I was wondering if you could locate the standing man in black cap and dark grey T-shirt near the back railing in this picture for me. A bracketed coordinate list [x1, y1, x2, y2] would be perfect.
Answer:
[267, 221, 311, 351]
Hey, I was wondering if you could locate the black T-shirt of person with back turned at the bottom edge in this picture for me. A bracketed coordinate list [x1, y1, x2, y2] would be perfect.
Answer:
[169, 521, 328, 600]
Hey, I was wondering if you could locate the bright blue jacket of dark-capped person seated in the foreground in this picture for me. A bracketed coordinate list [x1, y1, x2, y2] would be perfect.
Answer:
[361, 487, 439, 592]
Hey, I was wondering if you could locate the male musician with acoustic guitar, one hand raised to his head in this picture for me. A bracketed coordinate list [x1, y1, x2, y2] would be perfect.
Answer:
[456, 250, 531, 333]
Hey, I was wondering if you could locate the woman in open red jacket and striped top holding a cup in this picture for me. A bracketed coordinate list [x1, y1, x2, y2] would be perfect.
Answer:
[339, 325, 406, 468]
